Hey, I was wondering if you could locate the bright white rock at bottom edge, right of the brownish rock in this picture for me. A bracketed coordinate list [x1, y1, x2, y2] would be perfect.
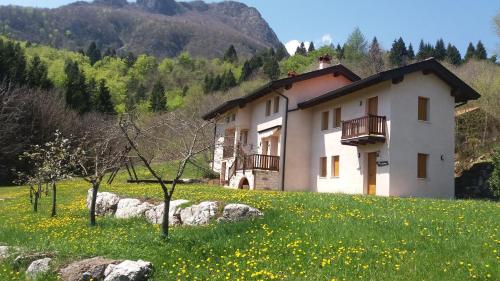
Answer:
[104, 260, 153, 281]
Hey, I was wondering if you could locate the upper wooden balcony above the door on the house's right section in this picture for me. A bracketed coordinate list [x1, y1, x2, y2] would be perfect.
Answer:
[340, 115, 386, 146]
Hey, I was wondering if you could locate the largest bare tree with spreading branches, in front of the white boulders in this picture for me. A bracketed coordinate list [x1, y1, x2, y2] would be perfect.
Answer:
[120, 110, 214, 238]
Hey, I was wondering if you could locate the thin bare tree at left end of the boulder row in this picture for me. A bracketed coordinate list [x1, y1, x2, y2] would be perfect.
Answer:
[74, 113, 127, 226]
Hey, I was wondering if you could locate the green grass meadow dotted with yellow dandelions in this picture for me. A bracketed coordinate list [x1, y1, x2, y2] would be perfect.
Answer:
[0, 174, 500, 280]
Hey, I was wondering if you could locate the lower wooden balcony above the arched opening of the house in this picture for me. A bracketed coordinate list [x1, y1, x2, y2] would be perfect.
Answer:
[229, 154, 280, 178]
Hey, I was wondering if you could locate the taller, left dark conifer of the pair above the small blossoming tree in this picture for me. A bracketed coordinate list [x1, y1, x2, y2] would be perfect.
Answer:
[64, 61, 91, 113]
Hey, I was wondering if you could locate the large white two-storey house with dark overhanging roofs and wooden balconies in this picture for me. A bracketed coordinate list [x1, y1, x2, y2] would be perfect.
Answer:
[203, 56, 480, 198]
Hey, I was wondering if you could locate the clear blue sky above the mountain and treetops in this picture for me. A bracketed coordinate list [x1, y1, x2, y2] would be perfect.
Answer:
[0, 0, 500, 55]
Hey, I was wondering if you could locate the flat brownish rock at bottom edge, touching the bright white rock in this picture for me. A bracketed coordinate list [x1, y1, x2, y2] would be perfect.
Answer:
[60, 257, 119, 281]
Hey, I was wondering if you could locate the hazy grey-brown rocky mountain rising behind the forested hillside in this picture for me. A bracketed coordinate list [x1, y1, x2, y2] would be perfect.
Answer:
[0, 0, 281, 58]
